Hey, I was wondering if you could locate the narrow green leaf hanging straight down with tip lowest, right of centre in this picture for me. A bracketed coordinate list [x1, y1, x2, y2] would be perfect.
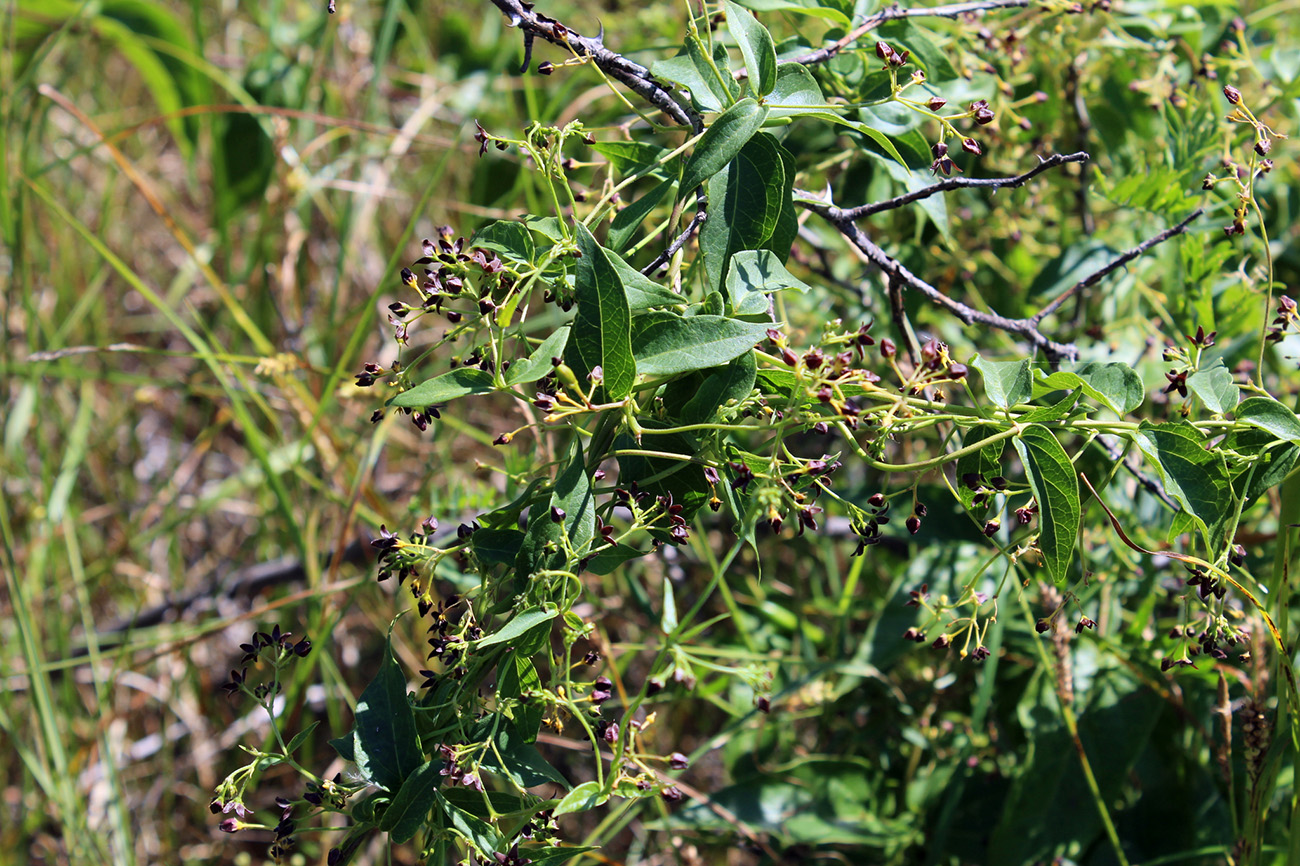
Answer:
[1015, 424, 1082, 584]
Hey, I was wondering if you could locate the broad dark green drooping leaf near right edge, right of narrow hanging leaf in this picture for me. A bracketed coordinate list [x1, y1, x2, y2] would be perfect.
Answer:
[1136, 421, 1234, 553]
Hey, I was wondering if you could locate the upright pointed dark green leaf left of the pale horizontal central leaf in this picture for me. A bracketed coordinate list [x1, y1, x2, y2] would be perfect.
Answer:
[564, 222, 637, 400]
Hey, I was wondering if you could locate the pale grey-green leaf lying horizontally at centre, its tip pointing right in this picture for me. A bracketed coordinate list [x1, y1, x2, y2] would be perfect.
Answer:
[632, 313, 768, 376]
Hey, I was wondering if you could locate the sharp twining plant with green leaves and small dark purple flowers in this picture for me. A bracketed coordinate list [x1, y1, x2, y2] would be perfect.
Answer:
[215, 0, 1300, 865]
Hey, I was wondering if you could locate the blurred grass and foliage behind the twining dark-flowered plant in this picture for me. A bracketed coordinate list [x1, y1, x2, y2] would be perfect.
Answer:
[0, 0, 1300, 865]
